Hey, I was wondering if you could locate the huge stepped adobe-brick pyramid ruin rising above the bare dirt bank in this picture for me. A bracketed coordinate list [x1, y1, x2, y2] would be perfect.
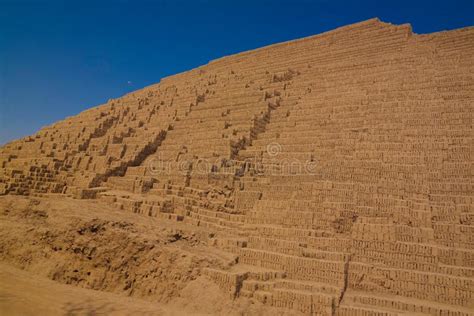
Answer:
[0, 19, 474, 315]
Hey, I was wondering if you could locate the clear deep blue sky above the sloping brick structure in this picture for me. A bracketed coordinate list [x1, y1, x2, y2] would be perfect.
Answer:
[0, 0, 474, 144]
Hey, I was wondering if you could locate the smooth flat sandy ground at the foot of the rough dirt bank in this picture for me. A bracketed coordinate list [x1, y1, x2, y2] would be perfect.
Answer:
[0, 264, 170, 316]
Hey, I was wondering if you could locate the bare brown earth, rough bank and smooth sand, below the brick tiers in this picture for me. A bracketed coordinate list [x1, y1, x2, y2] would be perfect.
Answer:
[0, 196, 304, 315]
